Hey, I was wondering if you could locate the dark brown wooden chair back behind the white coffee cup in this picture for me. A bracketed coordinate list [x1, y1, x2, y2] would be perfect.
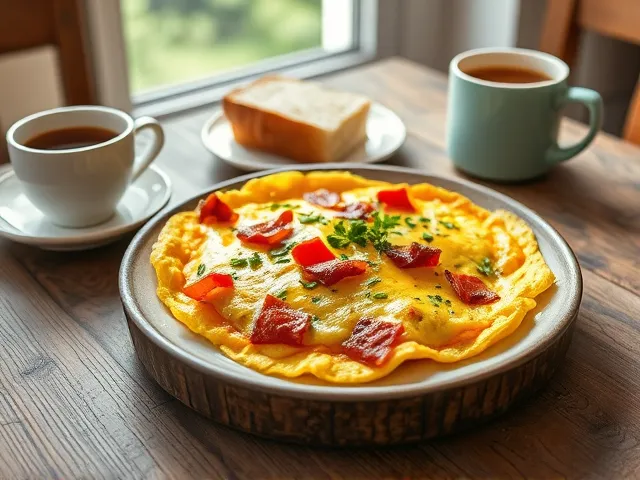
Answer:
[0, 0, 97, 163]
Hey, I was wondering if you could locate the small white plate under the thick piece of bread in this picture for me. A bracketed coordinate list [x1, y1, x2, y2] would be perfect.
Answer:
[201, 103, 407, 172]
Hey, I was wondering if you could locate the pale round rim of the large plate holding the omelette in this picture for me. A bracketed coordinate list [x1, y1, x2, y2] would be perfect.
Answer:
[118, 163, 583, 402]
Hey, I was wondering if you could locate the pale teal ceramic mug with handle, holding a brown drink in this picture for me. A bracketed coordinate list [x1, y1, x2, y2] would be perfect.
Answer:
[447, 48, 602, 182]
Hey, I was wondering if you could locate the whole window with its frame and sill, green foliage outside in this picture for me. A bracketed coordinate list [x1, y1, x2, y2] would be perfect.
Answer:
[88, 0, 394, 115]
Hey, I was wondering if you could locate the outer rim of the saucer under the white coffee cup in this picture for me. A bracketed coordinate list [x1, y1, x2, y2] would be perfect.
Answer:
[0, 165, 173, 247]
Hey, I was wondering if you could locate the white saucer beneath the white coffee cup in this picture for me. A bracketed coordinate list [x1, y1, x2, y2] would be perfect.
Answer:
[0, 166, 171, 251]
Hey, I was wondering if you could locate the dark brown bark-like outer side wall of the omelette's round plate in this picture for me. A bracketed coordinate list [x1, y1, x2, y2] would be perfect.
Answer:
[125, 311, 575, 447]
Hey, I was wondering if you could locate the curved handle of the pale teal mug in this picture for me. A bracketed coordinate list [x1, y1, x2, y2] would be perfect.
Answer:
[546, 87, 602, 165]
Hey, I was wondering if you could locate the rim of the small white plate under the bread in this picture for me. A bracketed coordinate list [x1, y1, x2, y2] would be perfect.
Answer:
[200, 101, 407, 172]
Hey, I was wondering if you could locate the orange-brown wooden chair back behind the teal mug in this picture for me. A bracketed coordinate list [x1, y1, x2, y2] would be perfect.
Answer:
[540, 0, 640, 145]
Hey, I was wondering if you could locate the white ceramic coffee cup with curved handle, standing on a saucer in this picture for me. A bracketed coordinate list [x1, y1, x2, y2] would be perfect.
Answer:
[7, 106, 164, 228]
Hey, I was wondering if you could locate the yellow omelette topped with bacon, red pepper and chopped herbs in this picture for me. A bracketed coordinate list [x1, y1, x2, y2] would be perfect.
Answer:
[151, 171, 554, 384]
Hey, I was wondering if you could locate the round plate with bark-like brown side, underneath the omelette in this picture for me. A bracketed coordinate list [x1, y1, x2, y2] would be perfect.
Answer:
[120, 164, 582, 446]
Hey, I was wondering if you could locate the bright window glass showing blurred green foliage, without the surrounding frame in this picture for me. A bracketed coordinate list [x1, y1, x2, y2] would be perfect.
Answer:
[122, 0, 353, 95]
